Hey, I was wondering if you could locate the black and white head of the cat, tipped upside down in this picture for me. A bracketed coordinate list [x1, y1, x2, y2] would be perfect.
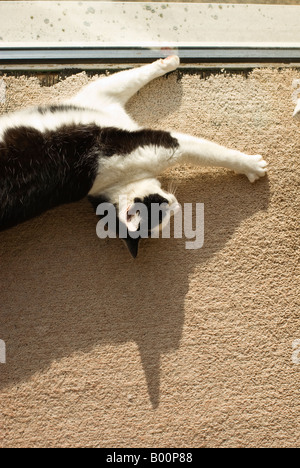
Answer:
[90, 179, 180, 258]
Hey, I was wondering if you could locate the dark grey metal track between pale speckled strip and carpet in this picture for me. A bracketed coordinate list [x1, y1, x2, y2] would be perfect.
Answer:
[0, 45, 300, 65]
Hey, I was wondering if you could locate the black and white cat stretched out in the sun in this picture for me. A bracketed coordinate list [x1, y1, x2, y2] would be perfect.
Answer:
[0, 56, 267, 257]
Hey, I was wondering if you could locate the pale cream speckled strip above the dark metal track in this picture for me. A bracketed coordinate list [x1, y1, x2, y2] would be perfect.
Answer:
[0, 0, 300, 45]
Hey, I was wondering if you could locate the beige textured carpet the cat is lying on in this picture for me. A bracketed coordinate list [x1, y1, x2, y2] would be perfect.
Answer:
[0, 69, 300, 447]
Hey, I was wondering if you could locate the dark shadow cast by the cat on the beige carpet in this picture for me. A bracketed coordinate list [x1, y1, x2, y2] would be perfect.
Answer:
[0, 172, 269, 408]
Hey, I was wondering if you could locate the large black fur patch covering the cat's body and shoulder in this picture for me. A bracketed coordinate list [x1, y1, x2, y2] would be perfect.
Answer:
[0, 121, 178, 230]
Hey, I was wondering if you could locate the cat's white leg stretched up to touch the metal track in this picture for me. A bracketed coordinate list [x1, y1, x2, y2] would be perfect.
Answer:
[69, 55, 180, 107]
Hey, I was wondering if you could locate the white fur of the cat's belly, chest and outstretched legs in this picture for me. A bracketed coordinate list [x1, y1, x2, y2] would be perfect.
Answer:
[0, 56, 267, 227]
